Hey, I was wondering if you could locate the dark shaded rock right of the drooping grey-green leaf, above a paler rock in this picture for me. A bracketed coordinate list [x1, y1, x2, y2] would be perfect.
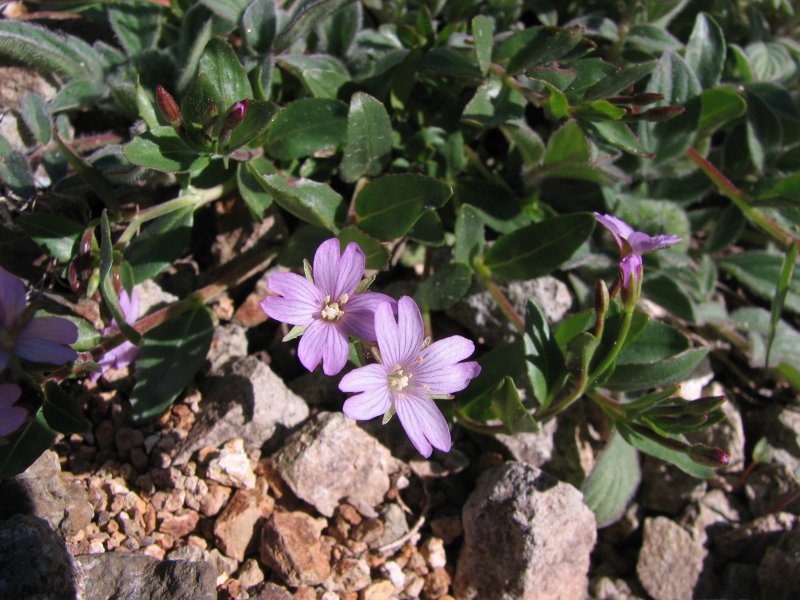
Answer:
[641, 456, 708, 515]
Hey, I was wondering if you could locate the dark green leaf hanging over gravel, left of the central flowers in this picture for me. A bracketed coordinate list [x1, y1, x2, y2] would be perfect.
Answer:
[131, 304, 214, 423]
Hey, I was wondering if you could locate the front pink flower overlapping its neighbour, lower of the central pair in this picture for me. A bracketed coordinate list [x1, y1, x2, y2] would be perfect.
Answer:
[339, 296, 481, 458]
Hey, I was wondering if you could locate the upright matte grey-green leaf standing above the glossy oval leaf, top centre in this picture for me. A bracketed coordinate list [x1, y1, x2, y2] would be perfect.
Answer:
[339, 92, 392, 183]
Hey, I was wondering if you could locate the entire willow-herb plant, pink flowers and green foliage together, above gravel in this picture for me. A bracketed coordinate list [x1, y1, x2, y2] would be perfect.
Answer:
[0, 0, 800, 525]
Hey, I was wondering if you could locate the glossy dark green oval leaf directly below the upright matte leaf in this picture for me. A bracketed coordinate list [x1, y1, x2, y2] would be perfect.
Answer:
[355, 173, 453, 241]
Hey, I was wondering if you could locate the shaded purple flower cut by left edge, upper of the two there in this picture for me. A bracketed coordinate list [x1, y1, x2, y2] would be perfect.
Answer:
[0, 267, 78, 371]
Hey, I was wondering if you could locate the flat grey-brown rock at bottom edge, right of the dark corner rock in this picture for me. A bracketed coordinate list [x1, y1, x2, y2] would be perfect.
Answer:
[76, 552, 217, 600]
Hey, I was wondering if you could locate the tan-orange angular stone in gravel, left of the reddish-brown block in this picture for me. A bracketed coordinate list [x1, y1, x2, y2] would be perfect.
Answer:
[214, 479, 275, 561]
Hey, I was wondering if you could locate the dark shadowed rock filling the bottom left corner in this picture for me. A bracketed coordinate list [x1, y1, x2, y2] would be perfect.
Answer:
[0, 515, 83, 600]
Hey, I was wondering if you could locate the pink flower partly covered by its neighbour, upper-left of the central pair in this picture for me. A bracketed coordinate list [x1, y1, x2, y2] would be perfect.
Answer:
[261, 238, 394, 375]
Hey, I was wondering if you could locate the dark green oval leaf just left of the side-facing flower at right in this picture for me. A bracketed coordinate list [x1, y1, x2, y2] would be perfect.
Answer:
[483, 213, 595, 279]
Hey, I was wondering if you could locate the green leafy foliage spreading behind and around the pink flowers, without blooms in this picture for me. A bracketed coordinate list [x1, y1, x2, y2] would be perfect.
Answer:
[0, 0, 800, 523]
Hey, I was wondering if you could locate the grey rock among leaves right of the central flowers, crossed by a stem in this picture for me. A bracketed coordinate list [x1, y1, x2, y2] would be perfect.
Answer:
[447, 275, 572, 346]
